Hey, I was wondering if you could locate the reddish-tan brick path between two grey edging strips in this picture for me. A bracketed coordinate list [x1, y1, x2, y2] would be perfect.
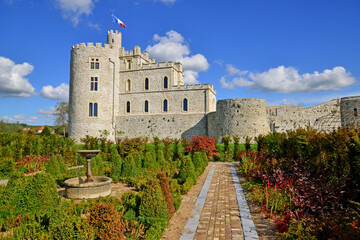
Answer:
[194, 163, 244, 240]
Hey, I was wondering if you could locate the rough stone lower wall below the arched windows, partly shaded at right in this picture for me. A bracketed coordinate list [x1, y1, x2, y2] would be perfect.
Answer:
[116, 114, 207, 138]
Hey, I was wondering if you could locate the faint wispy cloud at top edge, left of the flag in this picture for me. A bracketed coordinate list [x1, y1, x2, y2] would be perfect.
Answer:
[56, 0, 97, 26]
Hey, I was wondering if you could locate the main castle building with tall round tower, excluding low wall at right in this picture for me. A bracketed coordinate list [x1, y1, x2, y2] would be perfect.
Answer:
[69, 31, 216, 141]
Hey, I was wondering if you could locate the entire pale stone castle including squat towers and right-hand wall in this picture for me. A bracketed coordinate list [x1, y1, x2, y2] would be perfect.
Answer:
[69, 31, 360, 142]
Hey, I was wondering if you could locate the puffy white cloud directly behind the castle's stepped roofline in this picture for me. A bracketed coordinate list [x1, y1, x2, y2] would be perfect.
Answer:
[146, 30, 209, 84]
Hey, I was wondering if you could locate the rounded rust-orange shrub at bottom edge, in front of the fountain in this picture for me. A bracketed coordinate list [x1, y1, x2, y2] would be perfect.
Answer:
[89, 202, 125, 239]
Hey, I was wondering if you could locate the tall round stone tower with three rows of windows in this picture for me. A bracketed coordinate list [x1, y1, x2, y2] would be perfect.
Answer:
[69, 41, 115, 142]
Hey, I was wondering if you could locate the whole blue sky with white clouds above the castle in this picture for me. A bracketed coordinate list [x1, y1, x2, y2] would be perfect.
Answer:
[0, 0, 360, 125]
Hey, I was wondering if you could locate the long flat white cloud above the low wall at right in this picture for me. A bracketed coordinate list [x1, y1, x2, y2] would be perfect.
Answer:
[220, 65, 356, 93]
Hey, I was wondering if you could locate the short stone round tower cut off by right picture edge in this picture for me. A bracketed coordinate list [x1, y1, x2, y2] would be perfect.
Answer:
[340, 96, 360, 128]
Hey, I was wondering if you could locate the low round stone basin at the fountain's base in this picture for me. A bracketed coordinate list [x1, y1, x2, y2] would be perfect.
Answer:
[64, 176, 112, 199]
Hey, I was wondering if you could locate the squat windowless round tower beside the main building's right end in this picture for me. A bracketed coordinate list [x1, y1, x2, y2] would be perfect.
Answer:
[212, 98, 270, 142]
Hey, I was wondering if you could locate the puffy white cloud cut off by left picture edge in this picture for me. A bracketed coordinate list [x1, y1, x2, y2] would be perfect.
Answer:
[0, 57, 35, 97]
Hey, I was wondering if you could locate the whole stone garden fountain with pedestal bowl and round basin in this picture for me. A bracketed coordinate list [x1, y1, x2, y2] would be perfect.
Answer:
[64, 150, 112, 199]
